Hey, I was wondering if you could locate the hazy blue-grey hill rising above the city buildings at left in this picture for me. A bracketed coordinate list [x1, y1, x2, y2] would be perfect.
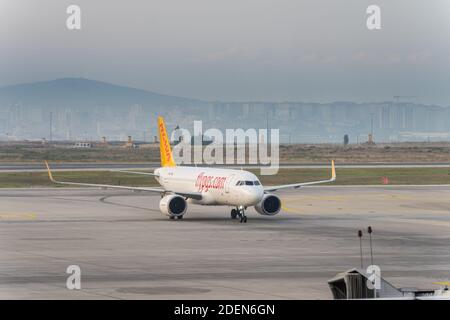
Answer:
[0, 78, 207, 109]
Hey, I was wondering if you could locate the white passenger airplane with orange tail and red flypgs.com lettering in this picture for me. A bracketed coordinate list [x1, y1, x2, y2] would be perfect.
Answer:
[45, 117, 336, 222]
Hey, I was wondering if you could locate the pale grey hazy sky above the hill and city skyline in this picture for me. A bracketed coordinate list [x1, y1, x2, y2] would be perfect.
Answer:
[0, 0, 450, 106]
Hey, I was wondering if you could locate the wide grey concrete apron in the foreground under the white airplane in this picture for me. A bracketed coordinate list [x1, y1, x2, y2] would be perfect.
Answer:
[0, 186, 450, 299]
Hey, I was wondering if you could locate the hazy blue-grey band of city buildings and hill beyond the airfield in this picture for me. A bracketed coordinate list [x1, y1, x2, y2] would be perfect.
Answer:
[0, 78, 450, 143]
